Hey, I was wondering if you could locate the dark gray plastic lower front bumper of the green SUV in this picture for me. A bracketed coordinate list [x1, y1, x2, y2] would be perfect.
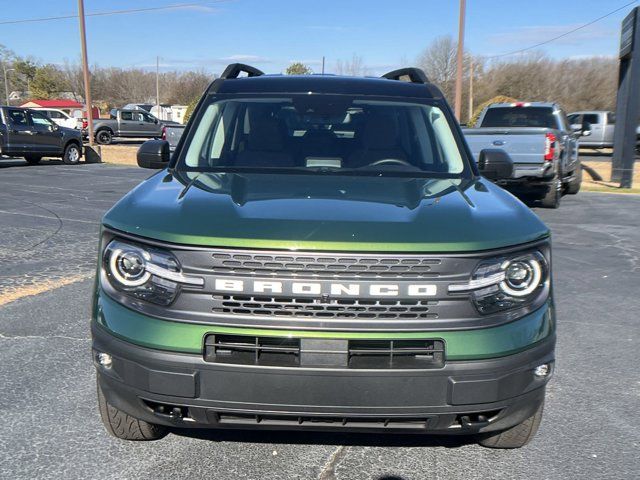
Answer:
[92, 316, 555, 434]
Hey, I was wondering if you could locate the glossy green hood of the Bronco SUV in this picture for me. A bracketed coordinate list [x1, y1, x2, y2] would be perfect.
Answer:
[103, 171, 549, 252]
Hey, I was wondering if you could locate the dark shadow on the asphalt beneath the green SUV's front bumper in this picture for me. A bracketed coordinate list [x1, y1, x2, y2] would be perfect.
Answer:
[171, 428, 477, 448]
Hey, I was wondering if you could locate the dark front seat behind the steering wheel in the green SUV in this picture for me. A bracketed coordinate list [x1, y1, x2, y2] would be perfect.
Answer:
[347, 115, 407, 168]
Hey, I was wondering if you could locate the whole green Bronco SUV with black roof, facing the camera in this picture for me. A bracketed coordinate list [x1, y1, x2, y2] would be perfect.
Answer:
[91, 64, 555, 448]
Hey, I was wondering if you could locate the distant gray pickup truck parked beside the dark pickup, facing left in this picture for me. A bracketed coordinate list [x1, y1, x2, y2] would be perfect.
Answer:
[93, 109, 164, 145]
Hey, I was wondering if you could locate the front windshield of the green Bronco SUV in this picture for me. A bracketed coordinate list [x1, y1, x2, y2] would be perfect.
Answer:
[178, 95, 464, 176]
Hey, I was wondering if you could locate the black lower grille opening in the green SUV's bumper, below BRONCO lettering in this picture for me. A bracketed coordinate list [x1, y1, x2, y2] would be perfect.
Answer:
[204, 334, 445, 369]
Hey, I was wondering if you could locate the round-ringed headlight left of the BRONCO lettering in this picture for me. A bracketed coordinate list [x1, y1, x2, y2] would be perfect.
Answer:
[102, 240, 204, 305]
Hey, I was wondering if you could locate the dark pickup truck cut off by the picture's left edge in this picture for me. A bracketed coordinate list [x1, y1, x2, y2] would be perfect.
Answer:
[0, 107, 82, 165]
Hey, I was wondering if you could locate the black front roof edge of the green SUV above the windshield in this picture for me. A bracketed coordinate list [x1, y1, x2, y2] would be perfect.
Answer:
[208, 75, 442, 99]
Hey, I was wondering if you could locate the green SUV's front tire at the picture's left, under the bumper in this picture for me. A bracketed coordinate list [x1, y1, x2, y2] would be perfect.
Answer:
[97, 383, 168, 441]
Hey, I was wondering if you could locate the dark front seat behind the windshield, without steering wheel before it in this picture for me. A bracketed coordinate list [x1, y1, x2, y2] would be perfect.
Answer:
[235, 116, 294, 167]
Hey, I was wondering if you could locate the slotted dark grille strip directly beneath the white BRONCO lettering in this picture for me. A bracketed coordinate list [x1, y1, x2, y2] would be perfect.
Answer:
[213, 295, 438, 320]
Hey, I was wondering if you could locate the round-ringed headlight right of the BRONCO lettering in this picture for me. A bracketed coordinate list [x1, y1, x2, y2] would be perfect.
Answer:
[449, 250, 549, 314]
